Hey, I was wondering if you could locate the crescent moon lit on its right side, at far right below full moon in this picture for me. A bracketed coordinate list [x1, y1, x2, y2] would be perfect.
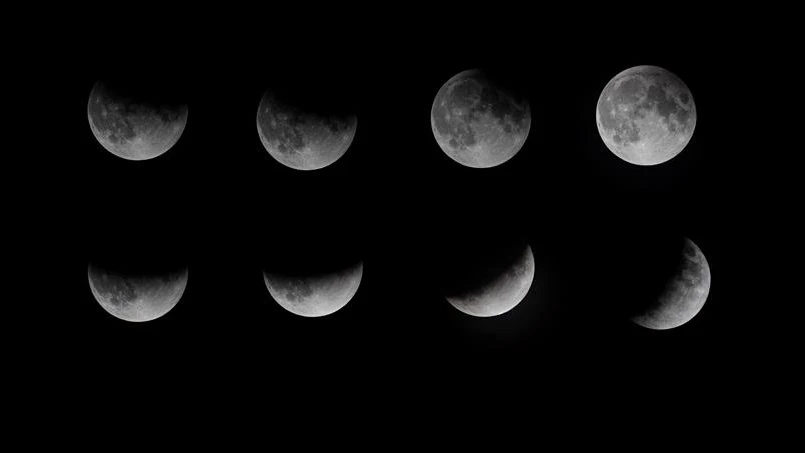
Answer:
[632, 238, 710, 330]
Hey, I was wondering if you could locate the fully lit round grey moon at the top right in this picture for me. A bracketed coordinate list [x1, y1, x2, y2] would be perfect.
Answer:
[595, 66, 696, 165]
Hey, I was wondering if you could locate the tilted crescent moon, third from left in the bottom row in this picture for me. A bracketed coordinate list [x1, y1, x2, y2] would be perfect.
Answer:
[446, 245, 534, 317]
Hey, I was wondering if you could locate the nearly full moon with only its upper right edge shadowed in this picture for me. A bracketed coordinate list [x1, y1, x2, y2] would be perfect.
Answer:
[431, 70, 531, 168]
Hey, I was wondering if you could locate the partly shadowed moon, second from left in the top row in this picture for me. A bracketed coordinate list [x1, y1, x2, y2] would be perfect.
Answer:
[257, 93, 358, 170]
